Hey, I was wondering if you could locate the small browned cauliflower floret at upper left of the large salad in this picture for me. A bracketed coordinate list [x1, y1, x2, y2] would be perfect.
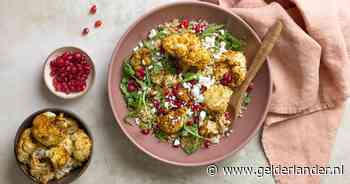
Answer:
[131, 48, 152, 69]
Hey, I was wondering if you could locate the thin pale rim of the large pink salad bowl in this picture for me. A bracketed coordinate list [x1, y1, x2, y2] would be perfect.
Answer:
[107, 0, 272, 167]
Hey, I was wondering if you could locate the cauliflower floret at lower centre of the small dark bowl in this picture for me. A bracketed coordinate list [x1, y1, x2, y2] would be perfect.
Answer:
[48, 147, 71, 169]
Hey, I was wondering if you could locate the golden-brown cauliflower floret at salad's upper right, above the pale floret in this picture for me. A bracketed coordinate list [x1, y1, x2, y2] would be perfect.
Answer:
[214, 50, 247, 87]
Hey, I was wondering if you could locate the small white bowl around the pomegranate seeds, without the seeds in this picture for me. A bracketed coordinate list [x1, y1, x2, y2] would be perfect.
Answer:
[43, 47, 95, 99]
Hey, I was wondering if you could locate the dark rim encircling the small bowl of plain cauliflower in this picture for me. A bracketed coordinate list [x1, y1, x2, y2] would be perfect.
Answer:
[14, 107, 94, 184]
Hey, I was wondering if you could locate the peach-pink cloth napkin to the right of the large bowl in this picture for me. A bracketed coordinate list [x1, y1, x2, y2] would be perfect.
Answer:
[200, 0, 350, 184]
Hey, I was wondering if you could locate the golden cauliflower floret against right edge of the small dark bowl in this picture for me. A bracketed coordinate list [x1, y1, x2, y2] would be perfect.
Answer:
[71, 129, 92, 162]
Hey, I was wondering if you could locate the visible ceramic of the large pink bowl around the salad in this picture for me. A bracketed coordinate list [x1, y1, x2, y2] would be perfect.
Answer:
[108, 1, 272, 166]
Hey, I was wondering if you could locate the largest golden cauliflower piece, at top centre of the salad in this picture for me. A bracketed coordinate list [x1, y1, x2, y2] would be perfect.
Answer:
[162, 33, 211, 69]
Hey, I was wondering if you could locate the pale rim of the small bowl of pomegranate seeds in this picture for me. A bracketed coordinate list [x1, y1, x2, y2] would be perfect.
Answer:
[42, 46, 96, 100]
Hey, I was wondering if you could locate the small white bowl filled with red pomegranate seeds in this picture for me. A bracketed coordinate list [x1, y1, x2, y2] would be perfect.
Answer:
[44, 47, 95, 99]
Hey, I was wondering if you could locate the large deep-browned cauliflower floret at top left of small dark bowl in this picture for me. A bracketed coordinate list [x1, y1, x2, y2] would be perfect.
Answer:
[32, 113, 65, 146]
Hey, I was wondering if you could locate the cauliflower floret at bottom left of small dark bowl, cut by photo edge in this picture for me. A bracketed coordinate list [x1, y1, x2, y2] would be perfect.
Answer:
[29, 149, 55, 184]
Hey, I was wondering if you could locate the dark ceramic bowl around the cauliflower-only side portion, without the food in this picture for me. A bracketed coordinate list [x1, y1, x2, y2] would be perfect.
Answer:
[14, 108, 94, 184]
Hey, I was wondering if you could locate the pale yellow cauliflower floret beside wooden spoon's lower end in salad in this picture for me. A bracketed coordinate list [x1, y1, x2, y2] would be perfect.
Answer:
[204, 84, 233, 113]
